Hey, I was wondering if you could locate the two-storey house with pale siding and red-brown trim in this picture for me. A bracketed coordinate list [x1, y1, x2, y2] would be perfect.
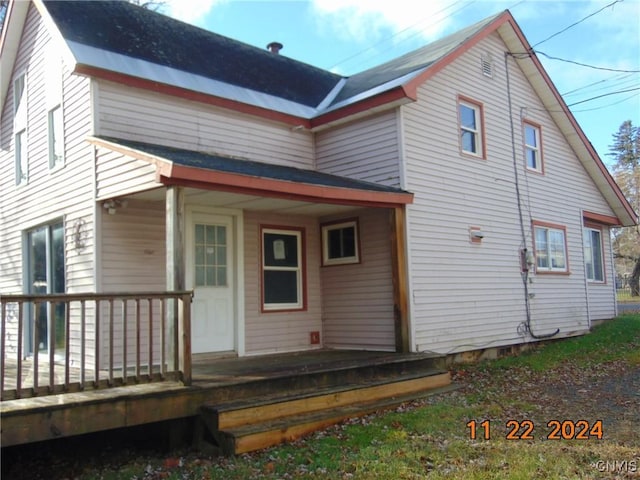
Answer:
[0, 0, 637, 378]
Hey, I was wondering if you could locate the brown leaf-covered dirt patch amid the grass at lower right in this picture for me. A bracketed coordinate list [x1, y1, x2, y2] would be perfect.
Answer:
[454, 361, 640, 444]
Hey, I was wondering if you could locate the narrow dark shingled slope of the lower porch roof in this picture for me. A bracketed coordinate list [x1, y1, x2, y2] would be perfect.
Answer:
[96, 136, 407, 193]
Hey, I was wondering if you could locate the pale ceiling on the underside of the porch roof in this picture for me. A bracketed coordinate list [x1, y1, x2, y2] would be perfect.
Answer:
[127, 188, 360, 216]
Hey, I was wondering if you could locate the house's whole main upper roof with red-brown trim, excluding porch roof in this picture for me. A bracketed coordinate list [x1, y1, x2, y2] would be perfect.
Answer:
[0, 0, 638, 226]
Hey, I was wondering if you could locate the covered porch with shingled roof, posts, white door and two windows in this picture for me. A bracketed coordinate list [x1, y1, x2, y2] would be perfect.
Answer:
[92, 138, 412, 356]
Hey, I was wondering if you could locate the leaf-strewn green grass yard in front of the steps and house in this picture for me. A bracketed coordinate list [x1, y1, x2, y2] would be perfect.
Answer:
[10, 315, 640, 480]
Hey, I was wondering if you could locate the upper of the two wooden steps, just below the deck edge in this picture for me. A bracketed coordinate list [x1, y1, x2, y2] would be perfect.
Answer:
[212, 372, 451, 430]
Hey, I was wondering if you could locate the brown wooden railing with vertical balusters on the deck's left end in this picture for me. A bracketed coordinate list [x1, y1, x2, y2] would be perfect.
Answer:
[0, 291, 192, 401]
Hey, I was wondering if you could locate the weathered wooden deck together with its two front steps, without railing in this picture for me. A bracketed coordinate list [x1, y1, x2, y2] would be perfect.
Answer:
[0, 350, 452, 454]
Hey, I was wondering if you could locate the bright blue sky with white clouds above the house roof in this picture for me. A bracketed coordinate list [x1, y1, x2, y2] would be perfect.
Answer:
[160, 0, 640, 166]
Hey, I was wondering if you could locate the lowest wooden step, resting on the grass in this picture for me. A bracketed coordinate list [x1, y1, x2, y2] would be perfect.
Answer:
[216, 385, 457, 456]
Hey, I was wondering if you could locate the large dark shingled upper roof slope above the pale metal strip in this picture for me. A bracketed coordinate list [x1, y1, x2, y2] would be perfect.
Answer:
[44, 1, 342, 107]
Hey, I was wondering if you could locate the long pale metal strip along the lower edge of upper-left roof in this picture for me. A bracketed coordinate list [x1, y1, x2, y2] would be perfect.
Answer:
[67, 41, 318, 118]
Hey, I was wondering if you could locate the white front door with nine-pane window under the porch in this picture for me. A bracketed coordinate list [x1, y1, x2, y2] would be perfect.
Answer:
[186, 212, 236, 353]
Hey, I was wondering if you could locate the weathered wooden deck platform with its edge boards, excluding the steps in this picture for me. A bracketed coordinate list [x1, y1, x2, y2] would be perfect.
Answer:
[0, 350, 449, 446]
